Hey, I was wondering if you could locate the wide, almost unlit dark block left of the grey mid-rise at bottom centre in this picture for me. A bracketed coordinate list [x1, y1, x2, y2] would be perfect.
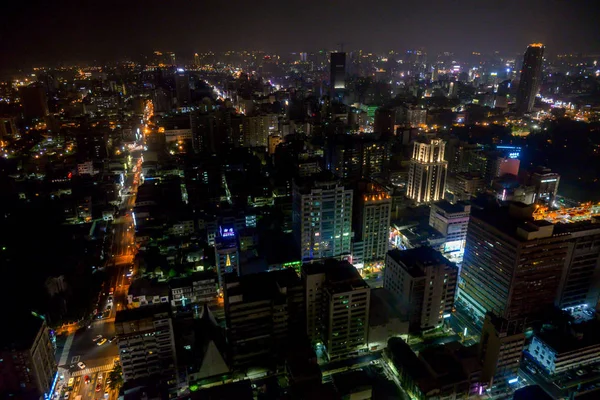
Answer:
[223, 268, 304, 369]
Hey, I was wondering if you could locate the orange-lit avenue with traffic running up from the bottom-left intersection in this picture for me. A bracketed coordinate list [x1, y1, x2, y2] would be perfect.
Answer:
[58, 154, 142, 400]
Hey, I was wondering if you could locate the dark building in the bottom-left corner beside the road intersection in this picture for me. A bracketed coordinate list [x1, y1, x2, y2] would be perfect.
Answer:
[0, 310, 58, 400]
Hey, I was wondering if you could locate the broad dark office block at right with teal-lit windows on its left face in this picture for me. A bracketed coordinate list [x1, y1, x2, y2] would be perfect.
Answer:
[458, 203, 570, 320]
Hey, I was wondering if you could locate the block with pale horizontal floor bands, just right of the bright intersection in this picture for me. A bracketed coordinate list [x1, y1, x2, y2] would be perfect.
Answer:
[115, 303, 177, 385]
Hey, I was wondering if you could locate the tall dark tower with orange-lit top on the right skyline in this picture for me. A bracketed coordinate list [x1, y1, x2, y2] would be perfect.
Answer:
[517, 43, 545, 114]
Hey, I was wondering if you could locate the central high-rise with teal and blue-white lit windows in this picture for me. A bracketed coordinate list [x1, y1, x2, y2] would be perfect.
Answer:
[292, 172, 352, 261]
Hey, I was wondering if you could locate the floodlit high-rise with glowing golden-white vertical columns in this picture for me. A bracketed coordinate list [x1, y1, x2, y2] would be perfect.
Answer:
[406, 138, 448, 204]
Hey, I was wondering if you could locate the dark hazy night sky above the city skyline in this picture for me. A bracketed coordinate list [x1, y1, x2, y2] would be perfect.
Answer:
[0, 0, 600, 69]
